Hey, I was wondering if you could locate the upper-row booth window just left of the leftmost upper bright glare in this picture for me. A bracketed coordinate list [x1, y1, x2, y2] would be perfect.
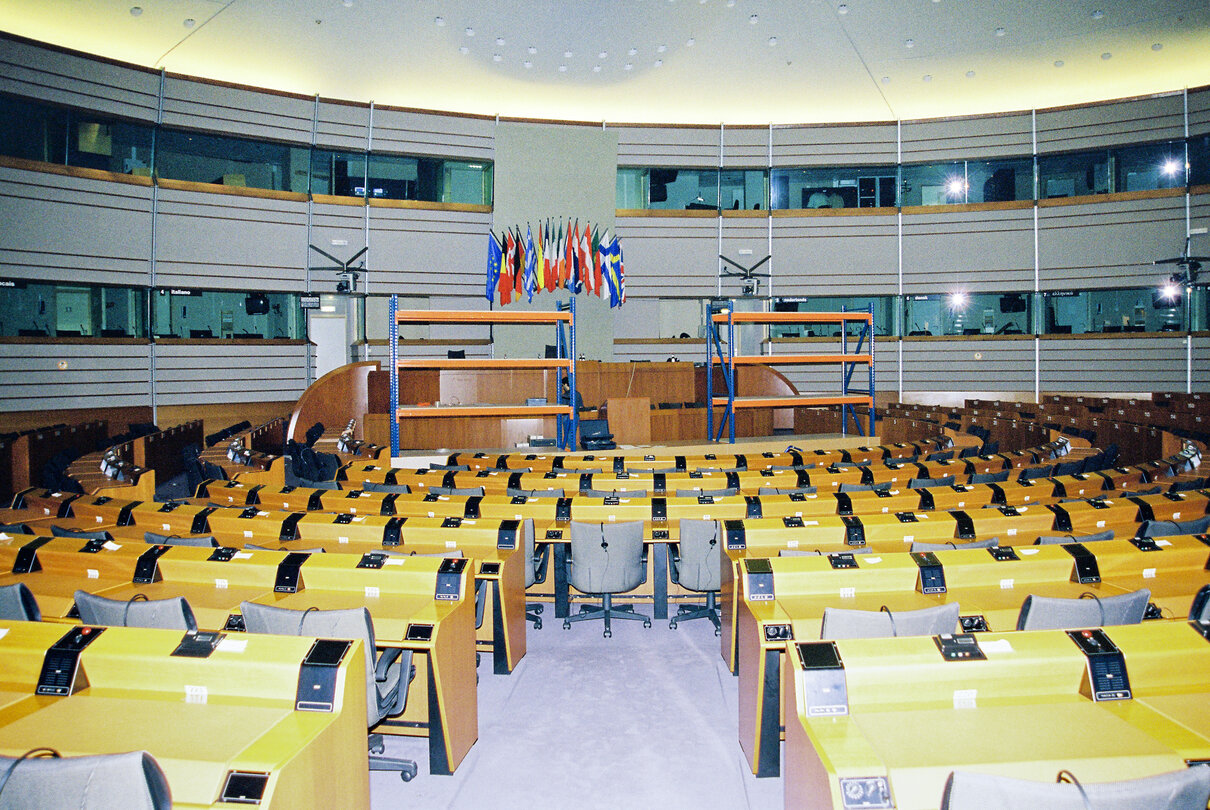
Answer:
[770, 166, 899, 209]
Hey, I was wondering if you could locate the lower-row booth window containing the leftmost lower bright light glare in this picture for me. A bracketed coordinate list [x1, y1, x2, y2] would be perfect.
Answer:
[904, 293, 1032, 337]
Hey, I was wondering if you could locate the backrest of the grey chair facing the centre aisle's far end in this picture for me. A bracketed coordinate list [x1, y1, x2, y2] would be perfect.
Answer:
[570, 521, 647, 593]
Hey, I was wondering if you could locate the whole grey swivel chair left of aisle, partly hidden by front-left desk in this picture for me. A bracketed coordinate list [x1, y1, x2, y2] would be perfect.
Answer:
[240, 602, 417, 782]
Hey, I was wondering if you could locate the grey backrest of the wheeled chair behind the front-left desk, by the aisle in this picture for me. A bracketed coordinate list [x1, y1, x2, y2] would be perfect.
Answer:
[240, 602, 384, 728]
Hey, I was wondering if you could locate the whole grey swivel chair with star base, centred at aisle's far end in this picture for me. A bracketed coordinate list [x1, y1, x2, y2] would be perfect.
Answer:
[563, 521, 651, 638]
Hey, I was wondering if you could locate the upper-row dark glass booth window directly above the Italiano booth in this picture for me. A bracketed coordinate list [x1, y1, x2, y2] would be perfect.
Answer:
[155, 130, 311, 193]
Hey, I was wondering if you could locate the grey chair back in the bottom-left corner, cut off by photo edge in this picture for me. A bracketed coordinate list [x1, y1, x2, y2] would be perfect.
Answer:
[0, 748, 172, 810]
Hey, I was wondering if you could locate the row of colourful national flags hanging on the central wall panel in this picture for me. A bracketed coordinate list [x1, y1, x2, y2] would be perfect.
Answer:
[484, 219, 626, 306]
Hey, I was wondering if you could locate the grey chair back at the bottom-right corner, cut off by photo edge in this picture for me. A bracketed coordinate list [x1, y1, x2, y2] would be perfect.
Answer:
[941, 766, 1210, 810]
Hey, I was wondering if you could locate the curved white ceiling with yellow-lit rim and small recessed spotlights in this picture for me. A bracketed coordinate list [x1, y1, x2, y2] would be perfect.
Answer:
[0, 0, 1210, 125]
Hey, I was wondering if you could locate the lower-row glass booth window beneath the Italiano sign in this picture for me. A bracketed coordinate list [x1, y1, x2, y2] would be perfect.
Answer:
[151, 288, 306, 340]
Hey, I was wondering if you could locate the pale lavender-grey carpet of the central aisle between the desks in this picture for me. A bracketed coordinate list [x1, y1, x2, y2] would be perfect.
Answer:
[370, 605, 783, 810]
